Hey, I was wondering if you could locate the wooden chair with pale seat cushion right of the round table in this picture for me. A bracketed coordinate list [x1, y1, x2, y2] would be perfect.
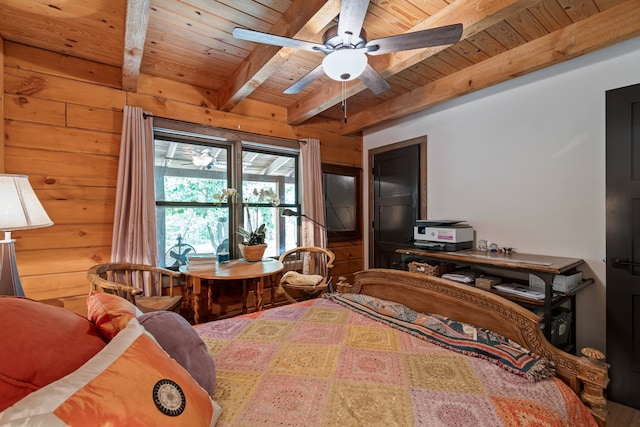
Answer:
[277, 246, 336, 303]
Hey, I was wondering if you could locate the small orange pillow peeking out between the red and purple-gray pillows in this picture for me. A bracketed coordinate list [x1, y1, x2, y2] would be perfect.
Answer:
[87, 291, 142, 341]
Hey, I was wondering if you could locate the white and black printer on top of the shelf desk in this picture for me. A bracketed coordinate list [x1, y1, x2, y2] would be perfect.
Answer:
[413, 220, 473, 251]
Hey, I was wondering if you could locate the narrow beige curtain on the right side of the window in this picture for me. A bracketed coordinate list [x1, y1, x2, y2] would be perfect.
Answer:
[300, 138, 327, 248]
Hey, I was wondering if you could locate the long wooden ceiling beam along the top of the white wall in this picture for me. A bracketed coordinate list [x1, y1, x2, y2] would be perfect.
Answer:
[343, 0, 640, 135]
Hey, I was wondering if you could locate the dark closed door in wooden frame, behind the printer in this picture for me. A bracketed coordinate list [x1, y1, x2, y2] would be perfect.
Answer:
[369, 144, 426, 269]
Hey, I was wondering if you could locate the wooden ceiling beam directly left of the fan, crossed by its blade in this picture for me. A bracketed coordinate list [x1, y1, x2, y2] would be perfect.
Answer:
[218, 0, 340, 111]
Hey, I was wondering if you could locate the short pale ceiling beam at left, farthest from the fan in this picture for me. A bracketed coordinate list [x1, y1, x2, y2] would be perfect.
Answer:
[122, 0, 151, 92]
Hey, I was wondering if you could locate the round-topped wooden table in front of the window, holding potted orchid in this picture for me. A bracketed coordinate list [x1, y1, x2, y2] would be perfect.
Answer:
[180, 258, 283, 323]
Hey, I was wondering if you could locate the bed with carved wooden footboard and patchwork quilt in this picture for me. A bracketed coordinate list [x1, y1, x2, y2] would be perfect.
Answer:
[195, 269, 608, 426]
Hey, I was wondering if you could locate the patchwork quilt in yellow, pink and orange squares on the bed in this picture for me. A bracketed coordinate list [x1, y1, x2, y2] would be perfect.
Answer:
[195, 294, 596, 427]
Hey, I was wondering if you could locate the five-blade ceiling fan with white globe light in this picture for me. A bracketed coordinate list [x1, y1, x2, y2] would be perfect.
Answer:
[232, 0, 462, 94]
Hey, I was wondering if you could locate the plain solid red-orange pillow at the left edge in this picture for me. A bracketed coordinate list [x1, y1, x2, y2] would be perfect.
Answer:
[0, 296, 106, 411]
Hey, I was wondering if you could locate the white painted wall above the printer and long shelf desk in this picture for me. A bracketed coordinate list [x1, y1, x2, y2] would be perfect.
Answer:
[363, 37, 640, 351]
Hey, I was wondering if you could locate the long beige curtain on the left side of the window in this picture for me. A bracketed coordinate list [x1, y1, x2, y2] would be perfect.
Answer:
[111, 106, 158, 265]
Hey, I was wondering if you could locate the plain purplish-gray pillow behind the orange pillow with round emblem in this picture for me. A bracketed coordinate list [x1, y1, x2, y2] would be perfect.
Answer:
[138, 311, 216, 396]
